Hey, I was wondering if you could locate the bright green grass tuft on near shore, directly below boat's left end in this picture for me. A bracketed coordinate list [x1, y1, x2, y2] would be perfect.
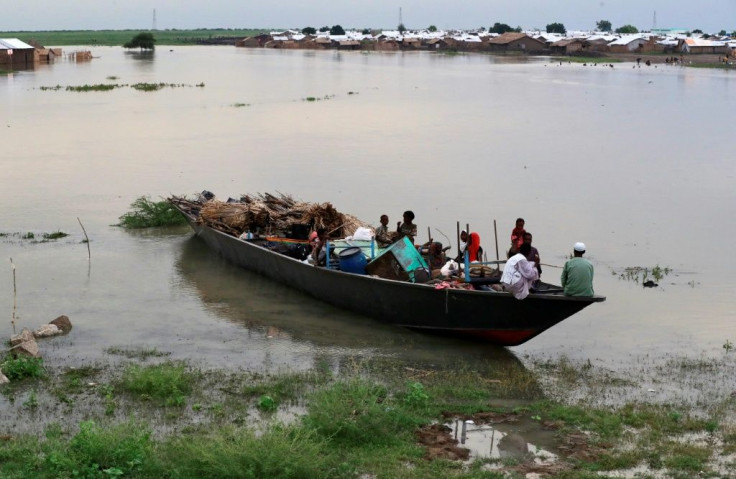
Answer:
[120, 361, 195, 406]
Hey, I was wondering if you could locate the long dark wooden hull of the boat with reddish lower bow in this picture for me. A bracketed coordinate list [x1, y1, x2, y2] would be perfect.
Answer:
[172, 201, 606, 346]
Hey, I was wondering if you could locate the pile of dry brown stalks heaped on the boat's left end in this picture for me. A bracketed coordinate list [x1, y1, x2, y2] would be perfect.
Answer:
[172, 193, 367, 237]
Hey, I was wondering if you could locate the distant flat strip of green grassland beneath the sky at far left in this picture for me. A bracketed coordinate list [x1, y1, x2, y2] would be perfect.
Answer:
[0, 28, 269, 46]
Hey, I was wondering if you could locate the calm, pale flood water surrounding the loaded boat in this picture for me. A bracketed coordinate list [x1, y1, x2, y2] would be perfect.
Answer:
[0, 47, 736, 382]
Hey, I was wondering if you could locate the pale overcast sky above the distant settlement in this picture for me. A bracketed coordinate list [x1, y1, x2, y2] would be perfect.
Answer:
[0, 0, 736, 33]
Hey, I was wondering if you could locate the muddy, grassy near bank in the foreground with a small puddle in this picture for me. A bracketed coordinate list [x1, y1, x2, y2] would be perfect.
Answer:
[0, 348, 736, 478]
